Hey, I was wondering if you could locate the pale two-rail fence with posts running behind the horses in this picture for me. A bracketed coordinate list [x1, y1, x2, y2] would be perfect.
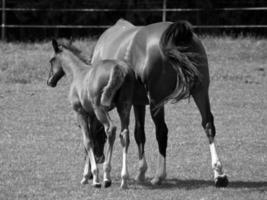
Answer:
[0, 0, 267, 40]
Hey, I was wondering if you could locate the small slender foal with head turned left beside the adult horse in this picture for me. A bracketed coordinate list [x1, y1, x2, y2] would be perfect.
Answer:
[47, 40, 134, 188]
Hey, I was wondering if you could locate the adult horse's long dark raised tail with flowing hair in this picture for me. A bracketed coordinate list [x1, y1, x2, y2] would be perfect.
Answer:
[160, 21, 200, 105]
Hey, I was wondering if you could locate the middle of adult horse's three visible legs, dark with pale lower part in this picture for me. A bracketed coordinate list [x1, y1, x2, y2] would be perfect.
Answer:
[150, 104, 168, 185]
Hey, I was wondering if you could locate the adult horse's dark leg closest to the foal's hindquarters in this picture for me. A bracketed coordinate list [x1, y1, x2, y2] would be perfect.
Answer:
[134, 105, 147, 182]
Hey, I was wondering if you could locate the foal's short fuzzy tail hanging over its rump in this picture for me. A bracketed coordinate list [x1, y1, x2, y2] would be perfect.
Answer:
[100, 61, 128, 106]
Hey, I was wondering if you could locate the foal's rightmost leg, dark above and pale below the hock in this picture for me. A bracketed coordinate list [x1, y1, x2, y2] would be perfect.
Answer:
[117, 103, 131, 189]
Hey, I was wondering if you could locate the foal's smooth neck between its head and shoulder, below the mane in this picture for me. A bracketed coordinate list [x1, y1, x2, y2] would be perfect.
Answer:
[62, 51, 90, 82]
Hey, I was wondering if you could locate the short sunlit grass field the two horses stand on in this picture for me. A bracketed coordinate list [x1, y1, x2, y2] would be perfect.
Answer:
[0, 37, 267, 200]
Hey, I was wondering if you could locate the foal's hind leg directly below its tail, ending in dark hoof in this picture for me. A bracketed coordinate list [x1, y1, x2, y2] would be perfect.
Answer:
[94, 108, 116, 188]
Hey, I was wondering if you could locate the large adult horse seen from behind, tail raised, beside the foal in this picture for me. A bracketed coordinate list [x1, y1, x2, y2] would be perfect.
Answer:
[91, 19, 228, 187]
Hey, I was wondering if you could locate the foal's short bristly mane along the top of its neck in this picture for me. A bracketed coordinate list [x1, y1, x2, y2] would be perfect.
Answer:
[58, 39, 91, 65]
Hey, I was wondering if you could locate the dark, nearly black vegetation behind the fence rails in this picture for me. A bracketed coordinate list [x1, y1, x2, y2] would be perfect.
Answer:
[2, 0, 267, 40]
